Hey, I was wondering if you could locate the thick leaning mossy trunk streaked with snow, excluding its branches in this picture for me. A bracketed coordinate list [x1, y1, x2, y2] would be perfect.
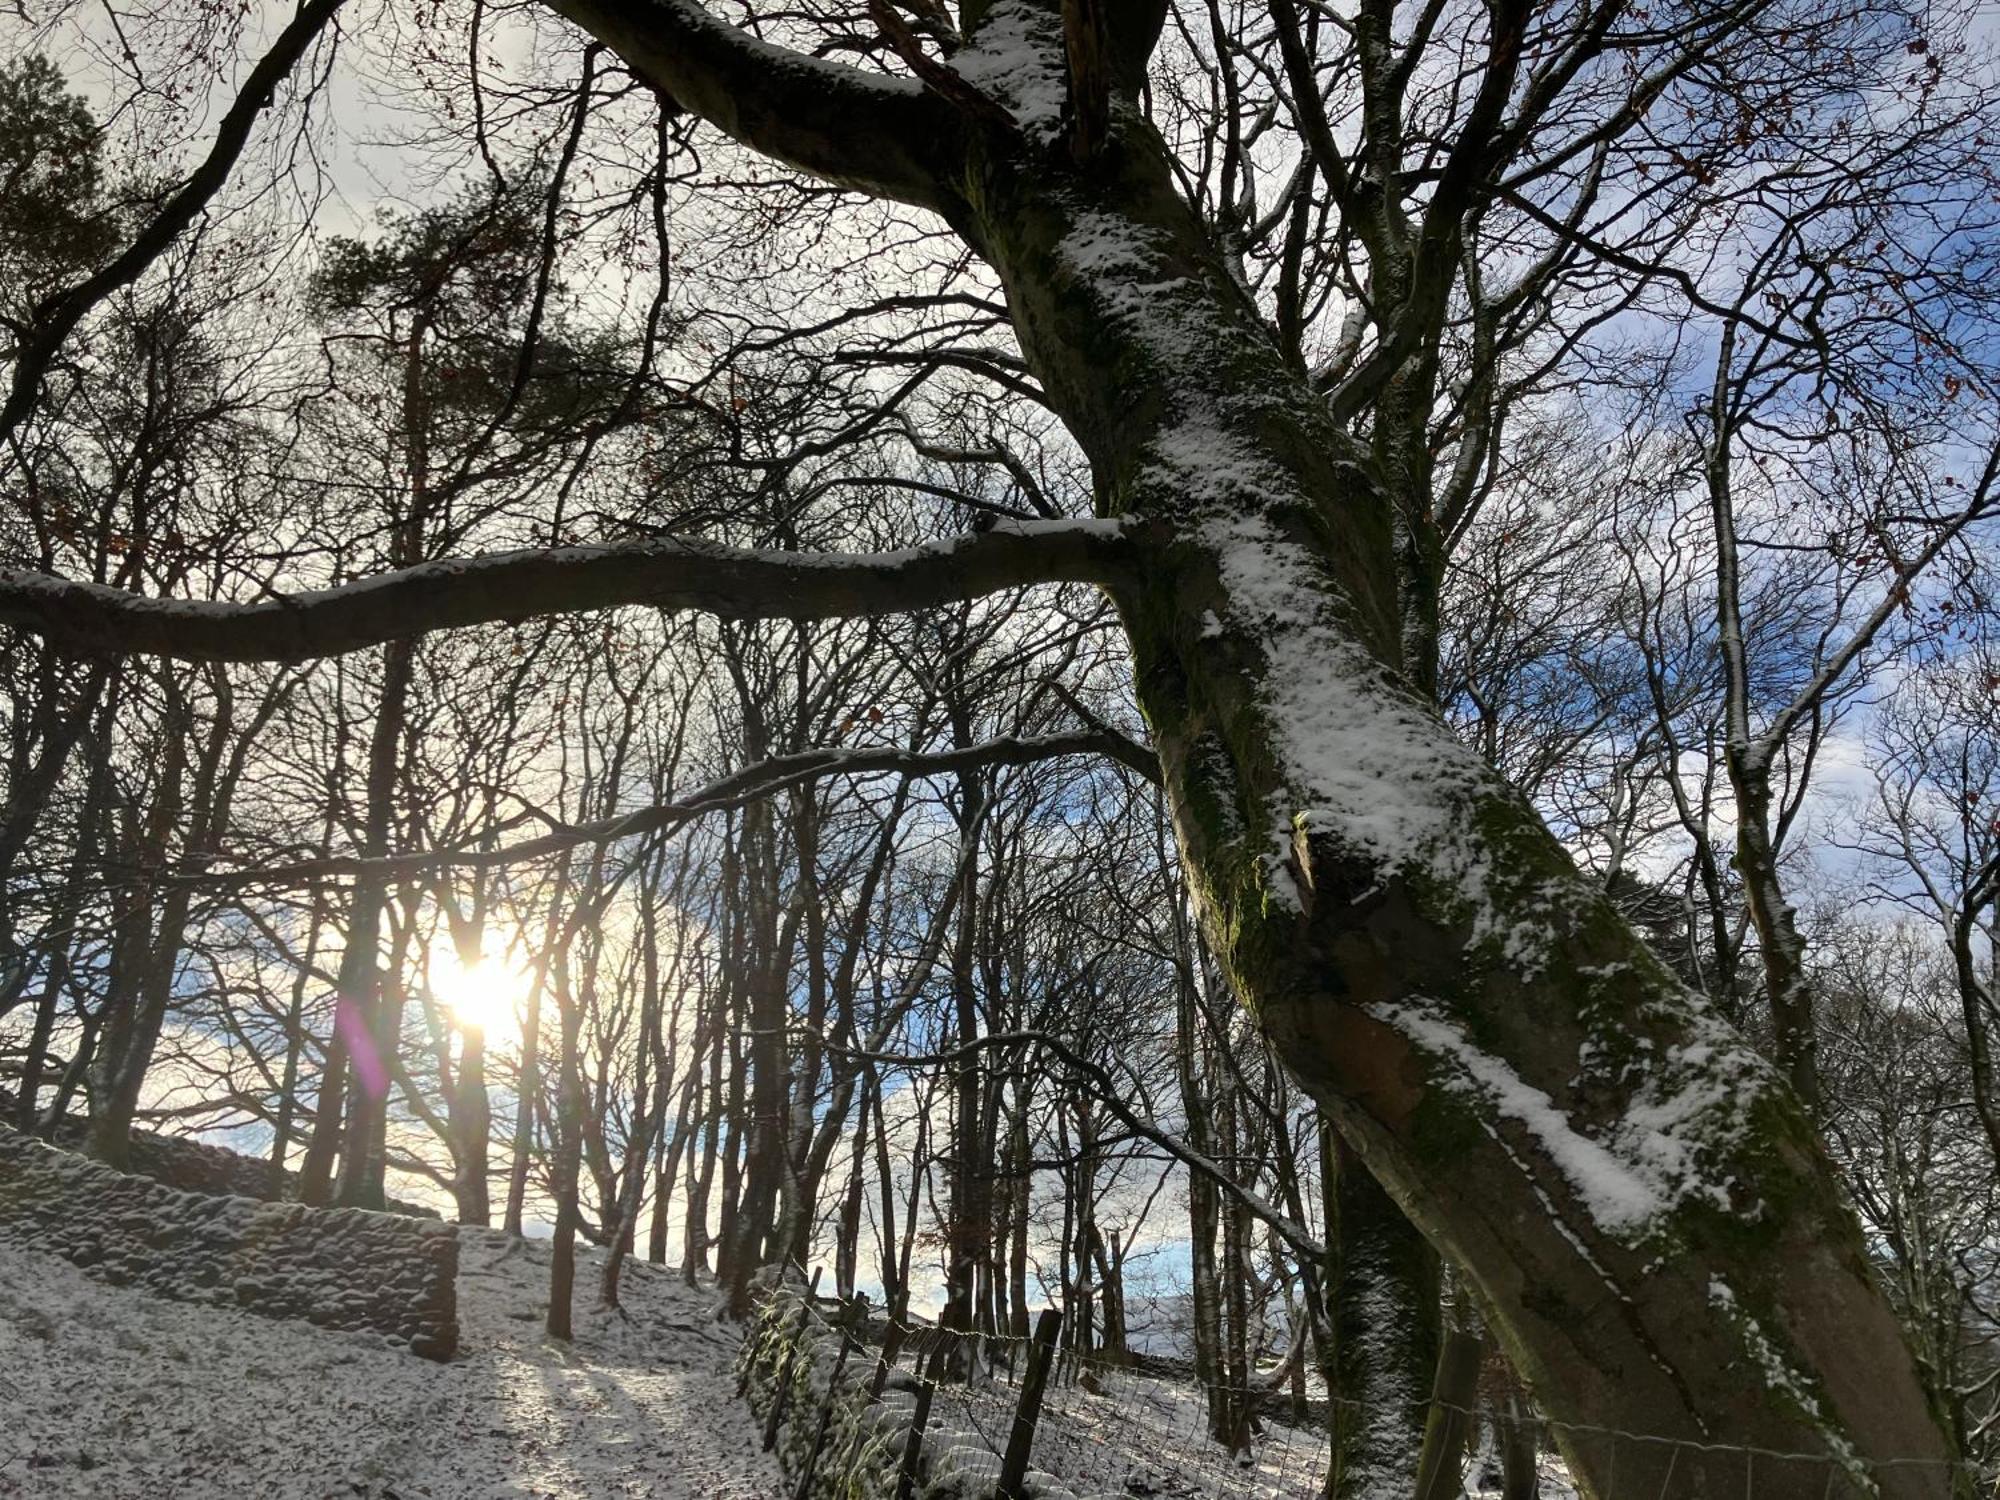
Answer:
[952, 64, 1958, 1498]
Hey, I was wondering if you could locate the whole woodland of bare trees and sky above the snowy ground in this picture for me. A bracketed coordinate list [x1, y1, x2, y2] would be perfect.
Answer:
[0, 0, 2000, 1500]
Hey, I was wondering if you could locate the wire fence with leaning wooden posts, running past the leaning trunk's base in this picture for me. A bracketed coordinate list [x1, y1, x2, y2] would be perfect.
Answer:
[744, 1288, 2000, 1500]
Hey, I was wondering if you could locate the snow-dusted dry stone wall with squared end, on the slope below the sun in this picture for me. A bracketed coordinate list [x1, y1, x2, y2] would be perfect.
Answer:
[0, 1128, 458, 1360]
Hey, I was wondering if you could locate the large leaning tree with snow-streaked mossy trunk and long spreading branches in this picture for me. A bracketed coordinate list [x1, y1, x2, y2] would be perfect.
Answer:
[0, 0, 1984, 1500]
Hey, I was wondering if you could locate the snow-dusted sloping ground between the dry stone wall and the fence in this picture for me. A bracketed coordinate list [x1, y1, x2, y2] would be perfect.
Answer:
[0, 1230, 788, 1500]
